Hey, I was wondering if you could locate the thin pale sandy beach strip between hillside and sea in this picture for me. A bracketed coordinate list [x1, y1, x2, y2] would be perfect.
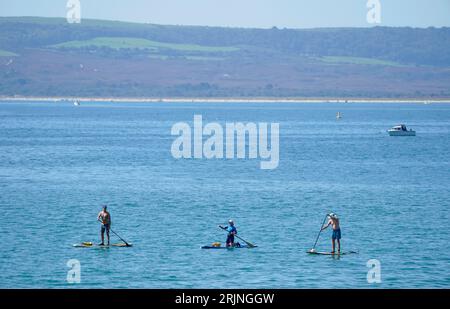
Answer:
[0, 96, 450, 104]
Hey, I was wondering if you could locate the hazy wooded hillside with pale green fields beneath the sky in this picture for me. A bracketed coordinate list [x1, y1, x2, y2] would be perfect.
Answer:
[0, 17, 450, 98]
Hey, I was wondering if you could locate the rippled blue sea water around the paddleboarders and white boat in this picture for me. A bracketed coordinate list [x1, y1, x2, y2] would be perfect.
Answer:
[0, 102, 450, 288]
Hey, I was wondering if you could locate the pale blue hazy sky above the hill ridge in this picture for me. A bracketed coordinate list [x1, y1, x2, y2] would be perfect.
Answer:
[0, 0, 450, 28]
